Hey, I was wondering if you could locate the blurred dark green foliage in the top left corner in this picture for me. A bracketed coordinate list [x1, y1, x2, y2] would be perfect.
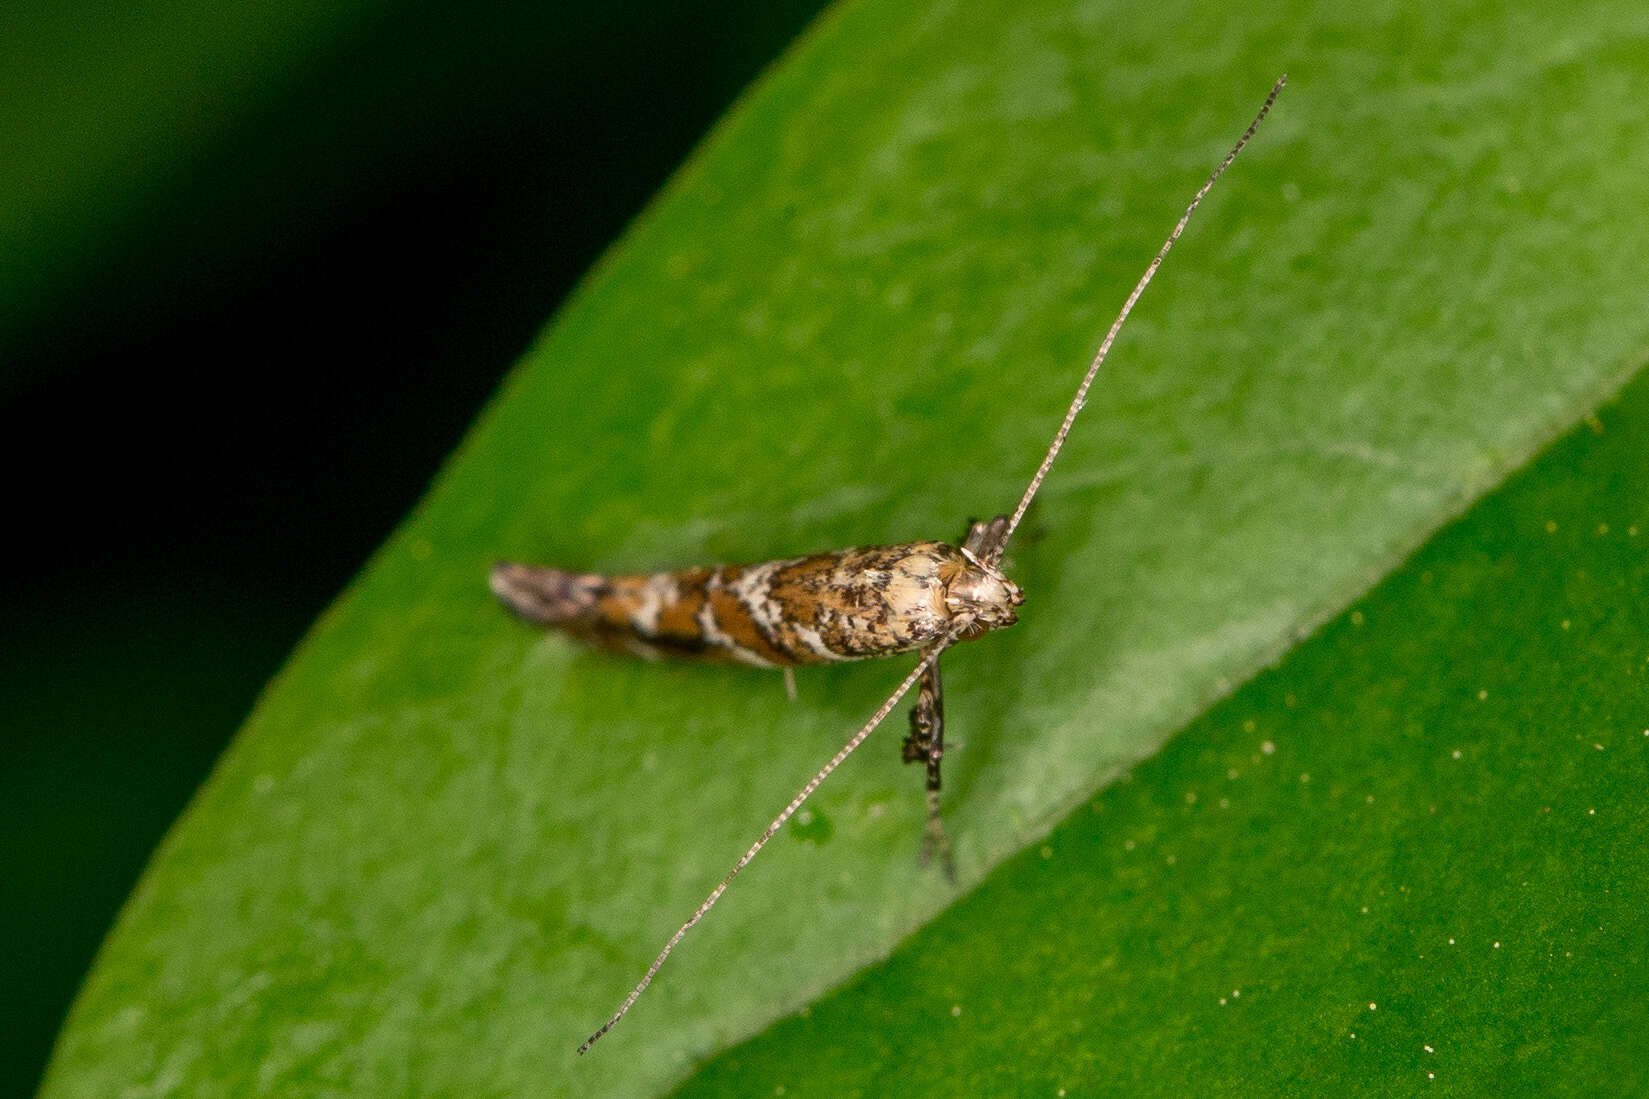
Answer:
[0, 0, 389, 369]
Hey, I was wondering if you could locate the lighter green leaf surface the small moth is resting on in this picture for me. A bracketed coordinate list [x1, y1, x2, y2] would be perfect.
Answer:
[35, 0, 1649, 1096]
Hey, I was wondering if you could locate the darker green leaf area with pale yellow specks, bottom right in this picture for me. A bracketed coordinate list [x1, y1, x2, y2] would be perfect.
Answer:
[678, 351, 1649, 1096]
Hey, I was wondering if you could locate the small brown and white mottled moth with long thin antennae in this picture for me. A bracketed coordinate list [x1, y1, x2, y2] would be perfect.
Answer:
[491, 76, 1288, 1053]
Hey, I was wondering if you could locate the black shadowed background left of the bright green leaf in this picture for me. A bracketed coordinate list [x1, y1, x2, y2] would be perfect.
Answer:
[0, 0, 823, 1094]
